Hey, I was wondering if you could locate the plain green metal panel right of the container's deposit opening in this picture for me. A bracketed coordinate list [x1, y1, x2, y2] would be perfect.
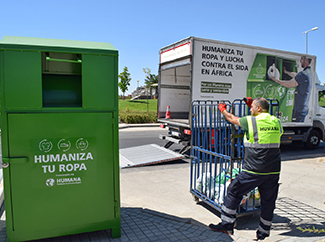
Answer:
[82, 54, 117, 110]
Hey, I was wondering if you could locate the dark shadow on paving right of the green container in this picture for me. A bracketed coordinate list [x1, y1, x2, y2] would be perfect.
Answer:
[117, 208, 232, 242]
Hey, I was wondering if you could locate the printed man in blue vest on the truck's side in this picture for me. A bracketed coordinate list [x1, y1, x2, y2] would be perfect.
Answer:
[272, 56, 313, 122]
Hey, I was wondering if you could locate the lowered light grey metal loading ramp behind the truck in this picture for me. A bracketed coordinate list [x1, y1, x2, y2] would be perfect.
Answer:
[120, 144, 184, 168]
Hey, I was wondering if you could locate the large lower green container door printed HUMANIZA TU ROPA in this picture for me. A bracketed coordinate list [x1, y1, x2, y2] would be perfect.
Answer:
[7, 113, 116, 234]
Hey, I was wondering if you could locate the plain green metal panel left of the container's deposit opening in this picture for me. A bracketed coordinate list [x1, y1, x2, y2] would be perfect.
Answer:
[1, 50, 42, 109]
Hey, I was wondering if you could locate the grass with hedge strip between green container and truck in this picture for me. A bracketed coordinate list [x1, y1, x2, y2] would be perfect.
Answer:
[119, 99, 157, 124]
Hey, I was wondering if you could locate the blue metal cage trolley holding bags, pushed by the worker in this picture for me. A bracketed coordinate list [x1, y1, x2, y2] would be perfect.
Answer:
[190, 99, 279, 217]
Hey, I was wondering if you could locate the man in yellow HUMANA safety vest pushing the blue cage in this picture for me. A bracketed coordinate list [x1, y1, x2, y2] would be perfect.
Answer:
[209, 98, 283, 240]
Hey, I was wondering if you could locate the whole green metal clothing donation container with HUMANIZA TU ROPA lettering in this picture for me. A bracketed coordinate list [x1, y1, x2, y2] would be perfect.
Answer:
[0, 37, 121, 241]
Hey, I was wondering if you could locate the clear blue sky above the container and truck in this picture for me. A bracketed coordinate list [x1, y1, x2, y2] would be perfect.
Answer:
[0, 0, 325, 93]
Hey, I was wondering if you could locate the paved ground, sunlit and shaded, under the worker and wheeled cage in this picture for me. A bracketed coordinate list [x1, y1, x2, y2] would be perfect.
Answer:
[0, 124, 325, 242]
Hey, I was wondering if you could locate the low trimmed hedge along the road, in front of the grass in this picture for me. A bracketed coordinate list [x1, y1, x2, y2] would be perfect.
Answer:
[119, 110, 157, 124]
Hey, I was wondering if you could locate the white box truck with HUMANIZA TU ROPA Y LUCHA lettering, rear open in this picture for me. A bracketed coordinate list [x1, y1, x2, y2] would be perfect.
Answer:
[157, 37, 325, 153]
